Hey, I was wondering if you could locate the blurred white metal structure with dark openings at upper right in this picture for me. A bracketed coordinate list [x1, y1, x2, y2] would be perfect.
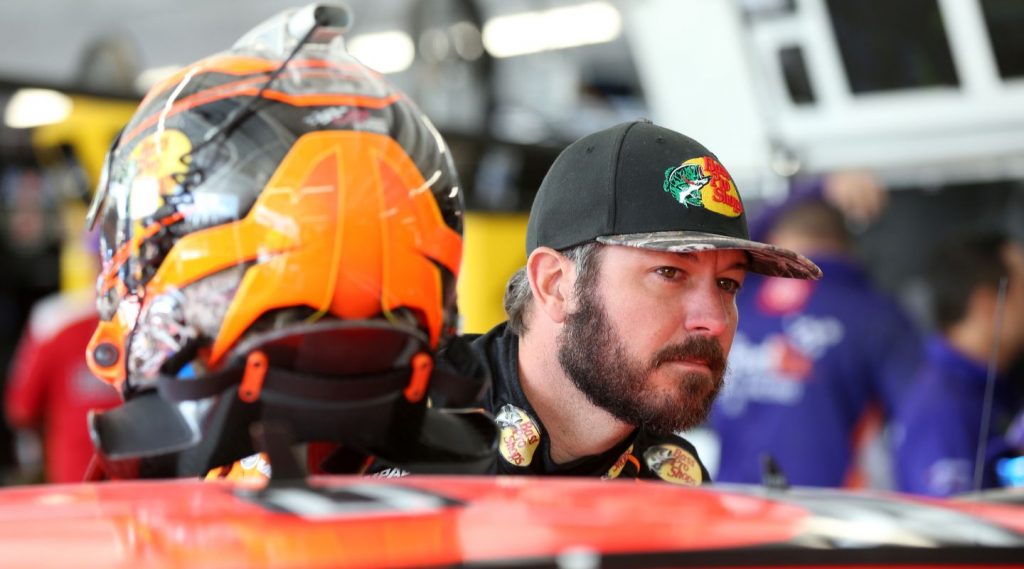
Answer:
[630, 0, 1024, 187]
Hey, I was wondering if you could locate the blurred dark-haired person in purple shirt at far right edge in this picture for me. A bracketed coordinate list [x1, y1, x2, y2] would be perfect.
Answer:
[894, 233, 1024, 496]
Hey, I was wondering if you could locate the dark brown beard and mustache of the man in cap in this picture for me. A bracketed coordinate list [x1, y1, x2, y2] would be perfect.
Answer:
[558, 290, 725, 434]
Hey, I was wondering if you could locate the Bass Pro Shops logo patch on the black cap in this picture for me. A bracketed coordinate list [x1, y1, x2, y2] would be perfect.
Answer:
[662, 157, 743, 217]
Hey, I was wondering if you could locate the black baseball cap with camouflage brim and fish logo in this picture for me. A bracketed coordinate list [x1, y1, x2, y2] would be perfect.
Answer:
[526, 120, 821, 279]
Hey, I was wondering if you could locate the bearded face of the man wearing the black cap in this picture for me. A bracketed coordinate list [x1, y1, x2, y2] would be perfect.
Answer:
[558, 247, 748, 433]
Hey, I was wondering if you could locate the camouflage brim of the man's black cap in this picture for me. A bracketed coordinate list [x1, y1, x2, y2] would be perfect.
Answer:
[597, 231, 821, 280]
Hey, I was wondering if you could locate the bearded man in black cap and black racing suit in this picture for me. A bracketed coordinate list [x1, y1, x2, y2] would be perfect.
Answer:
[464, 121, 821, 484]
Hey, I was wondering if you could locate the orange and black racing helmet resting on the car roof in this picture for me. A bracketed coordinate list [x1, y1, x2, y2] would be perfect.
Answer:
[86, 4, 491, 474]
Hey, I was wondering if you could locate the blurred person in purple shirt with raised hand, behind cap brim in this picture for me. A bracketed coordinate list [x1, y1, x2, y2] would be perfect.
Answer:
[711, 173, 921, 486]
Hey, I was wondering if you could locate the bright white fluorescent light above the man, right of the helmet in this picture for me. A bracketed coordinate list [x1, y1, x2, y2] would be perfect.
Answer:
[483, 2, 623, 57]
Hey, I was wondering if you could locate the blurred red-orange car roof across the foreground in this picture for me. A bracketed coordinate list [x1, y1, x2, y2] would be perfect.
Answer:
[0, 477, 1024, 569]
